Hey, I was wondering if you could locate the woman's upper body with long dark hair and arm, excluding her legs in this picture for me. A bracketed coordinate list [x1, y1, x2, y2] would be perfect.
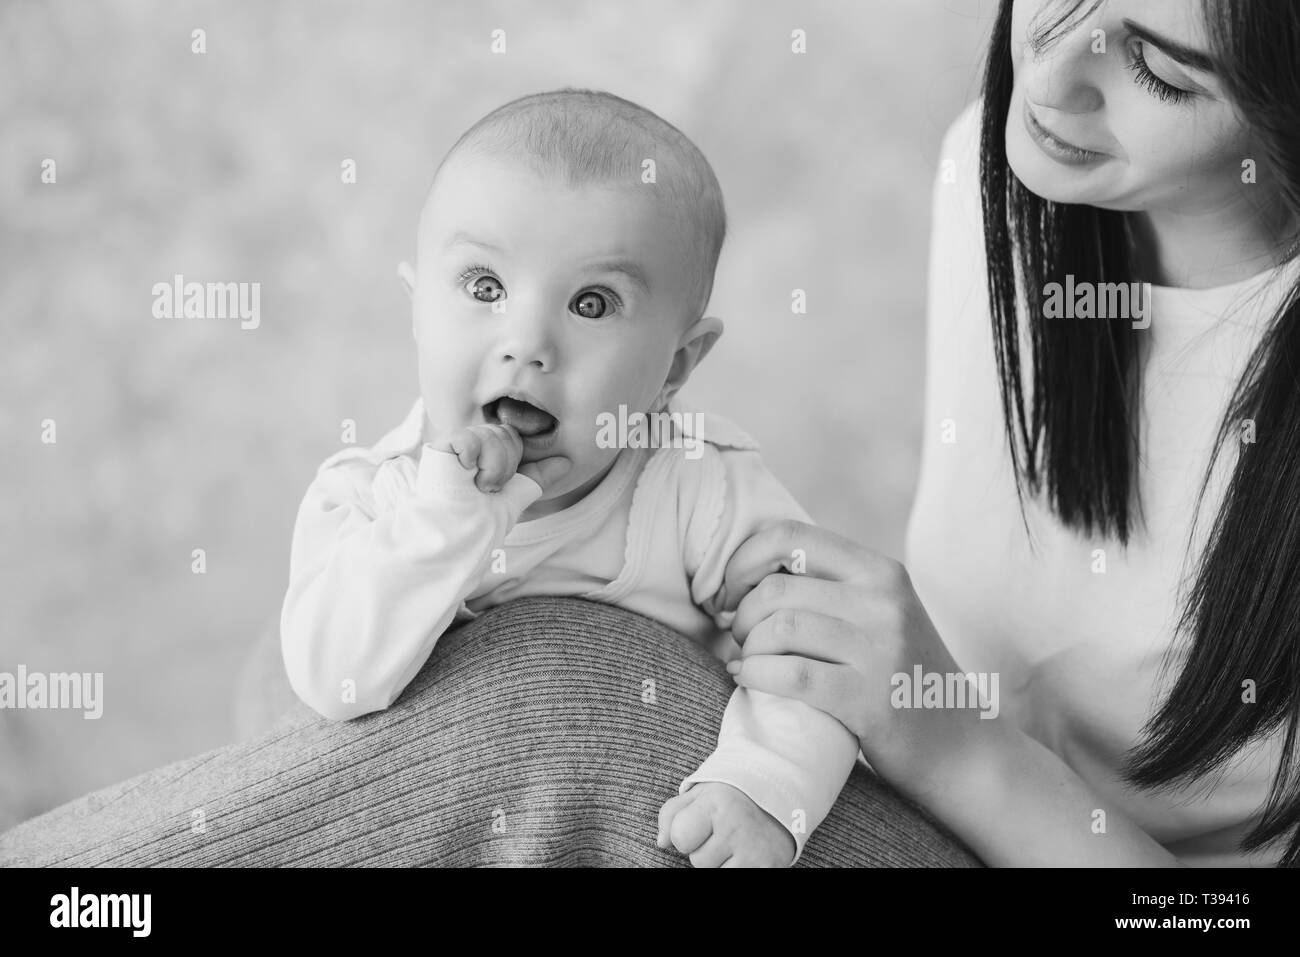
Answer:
[728, 0, 1300, 865]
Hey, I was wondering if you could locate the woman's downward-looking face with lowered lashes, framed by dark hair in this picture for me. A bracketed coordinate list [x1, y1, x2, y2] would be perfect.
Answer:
[1006, 0, 1251, 215]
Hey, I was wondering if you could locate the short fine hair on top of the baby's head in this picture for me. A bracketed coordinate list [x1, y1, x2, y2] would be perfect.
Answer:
[430, 87, 727, 319]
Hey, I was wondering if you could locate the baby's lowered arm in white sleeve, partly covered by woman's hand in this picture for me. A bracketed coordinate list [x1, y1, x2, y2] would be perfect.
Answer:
[660, 450, 858, 865]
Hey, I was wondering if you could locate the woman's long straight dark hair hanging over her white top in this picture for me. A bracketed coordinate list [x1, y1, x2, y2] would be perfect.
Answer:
[980, 0, 1300, 866]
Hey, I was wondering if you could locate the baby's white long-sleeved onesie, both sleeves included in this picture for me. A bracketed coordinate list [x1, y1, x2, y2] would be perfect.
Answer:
[281, 400, 858, 861]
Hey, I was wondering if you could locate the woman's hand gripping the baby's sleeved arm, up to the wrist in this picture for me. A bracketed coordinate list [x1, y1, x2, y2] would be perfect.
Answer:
[723, 521, 1001, 802]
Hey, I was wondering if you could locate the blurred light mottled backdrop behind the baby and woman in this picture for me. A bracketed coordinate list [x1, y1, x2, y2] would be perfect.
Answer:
[0, 0, 996, 828]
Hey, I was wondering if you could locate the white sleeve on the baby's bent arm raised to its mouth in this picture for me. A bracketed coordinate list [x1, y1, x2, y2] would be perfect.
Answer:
[280, 446, 542, 720]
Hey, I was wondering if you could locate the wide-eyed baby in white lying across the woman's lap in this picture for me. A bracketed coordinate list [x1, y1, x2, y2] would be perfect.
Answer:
[281, 90, 858, 866]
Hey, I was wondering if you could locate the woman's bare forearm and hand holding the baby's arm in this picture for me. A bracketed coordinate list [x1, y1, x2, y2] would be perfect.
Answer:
[724, 521, 1178, 866]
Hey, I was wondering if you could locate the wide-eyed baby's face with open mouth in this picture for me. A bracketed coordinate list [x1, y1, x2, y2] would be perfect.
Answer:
[412, 153, 697, 511]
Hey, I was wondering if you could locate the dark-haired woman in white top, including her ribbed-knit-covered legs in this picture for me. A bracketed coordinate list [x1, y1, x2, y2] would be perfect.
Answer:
[0, 0, 1300, 866]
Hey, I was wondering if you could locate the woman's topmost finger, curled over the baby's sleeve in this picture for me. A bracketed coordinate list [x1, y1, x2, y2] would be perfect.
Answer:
[722, 520, 898, 611]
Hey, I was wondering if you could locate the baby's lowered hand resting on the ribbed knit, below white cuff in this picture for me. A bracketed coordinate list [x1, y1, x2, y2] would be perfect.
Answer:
[658, 781, 794, 867]
